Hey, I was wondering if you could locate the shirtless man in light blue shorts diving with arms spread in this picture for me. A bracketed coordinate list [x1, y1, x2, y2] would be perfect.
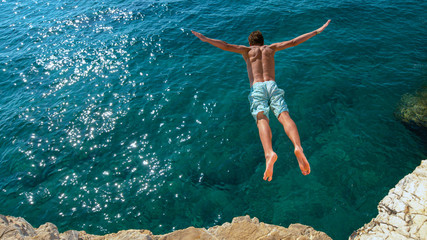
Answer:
[191, 20, 331, 181]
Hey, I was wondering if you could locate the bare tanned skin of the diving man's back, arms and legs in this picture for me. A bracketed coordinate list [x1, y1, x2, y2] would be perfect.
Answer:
[191, 20, 331, 181]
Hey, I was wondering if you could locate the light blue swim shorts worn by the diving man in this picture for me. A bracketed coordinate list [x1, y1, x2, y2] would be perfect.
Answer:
[249, 80, 289, 121]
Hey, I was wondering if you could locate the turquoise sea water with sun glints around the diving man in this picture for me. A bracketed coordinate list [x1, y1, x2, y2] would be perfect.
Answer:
[0, 0, 427, 239]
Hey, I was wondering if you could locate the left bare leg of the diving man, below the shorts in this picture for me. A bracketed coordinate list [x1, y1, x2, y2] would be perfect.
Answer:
[257, 112, 277, 181]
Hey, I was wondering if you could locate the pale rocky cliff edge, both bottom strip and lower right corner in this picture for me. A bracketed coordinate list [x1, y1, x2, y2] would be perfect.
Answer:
[0, 160, 427, 240]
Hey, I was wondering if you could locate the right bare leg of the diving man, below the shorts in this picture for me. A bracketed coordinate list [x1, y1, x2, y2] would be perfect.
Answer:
[278, 111, 310, 175]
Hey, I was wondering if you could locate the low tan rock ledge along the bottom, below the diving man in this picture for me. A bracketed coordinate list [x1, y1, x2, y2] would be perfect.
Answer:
[0, 215, 332, 240]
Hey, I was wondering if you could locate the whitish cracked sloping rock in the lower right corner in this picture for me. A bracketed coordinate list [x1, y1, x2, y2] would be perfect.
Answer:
[350, 160, 427, 240]
